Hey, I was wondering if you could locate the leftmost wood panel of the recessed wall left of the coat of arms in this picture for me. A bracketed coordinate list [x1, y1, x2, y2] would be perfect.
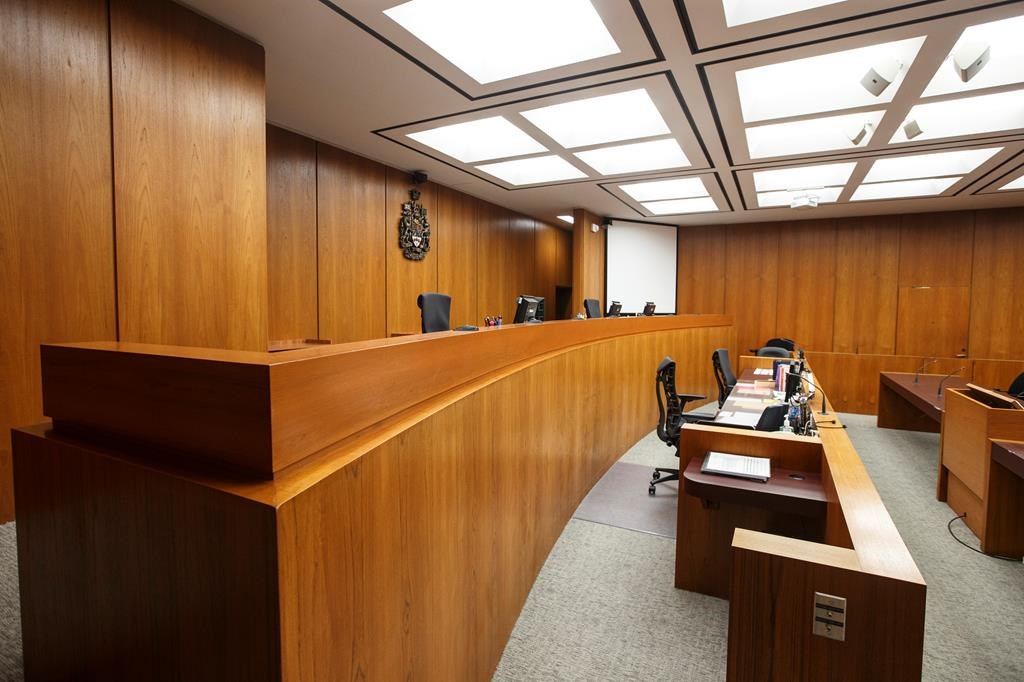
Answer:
[266, 126, 318, 339]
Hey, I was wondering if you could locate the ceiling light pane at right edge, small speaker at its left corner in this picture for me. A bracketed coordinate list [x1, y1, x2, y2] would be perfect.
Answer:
[890, 90, 1024, 144]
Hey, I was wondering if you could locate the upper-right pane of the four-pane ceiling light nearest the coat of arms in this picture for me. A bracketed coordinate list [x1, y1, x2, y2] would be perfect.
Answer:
[522, 88, 670, 148]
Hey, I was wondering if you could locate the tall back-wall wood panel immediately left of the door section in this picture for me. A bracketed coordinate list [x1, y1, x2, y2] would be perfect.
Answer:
[831, 216, 899, 356]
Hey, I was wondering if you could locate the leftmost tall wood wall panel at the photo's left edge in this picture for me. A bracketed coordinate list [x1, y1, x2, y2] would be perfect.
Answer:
[0, 0, 117, 522]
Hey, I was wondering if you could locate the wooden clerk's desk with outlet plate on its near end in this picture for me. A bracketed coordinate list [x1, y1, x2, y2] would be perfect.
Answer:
[676, 356, 926, 682]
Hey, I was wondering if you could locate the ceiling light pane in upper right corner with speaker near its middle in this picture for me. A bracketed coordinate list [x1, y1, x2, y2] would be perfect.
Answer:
[924, 15, 1024, 97]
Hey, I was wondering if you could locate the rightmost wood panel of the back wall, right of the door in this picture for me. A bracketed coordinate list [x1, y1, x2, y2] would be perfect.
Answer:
[971, 208, 1024, 358]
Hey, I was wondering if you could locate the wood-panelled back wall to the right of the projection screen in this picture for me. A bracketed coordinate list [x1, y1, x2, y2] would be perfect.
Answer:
[678, 208, 1024, 413]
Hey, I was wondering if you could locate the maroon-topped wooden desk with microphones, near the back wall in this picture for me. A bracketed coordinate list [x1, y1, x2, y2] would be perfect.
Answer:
[878, 372, 968, 433]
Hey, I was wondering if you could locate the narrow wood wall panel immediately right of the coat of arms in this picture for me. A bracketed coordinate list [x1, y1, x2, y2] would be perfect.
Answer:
[428, 185, 480, 329]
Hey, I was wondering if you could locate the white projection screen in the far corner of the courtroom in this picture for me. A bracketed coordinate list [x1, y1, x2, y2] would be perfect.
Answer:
[604, 220, 678, 314]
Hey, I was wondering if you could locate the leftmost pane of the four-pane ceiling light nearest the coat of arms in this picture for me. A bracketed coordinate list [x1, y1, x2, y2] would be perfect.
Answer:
[409, 116, 548, 163]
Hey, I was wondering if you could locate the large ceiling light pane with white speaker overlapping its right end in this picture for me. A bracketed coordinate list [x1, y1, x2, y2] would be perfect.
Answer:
[736, 37, 925, 123]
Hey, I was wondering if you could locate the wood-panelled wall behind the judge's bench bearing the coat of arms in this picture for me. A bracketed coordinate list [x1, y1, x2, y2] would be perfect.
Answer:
[267, 126, 573, 343]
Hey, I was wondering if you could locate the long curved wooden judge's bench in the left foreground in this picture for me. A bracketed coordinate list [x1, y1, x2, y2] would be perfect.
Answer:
[13, 315, 735, 682]
